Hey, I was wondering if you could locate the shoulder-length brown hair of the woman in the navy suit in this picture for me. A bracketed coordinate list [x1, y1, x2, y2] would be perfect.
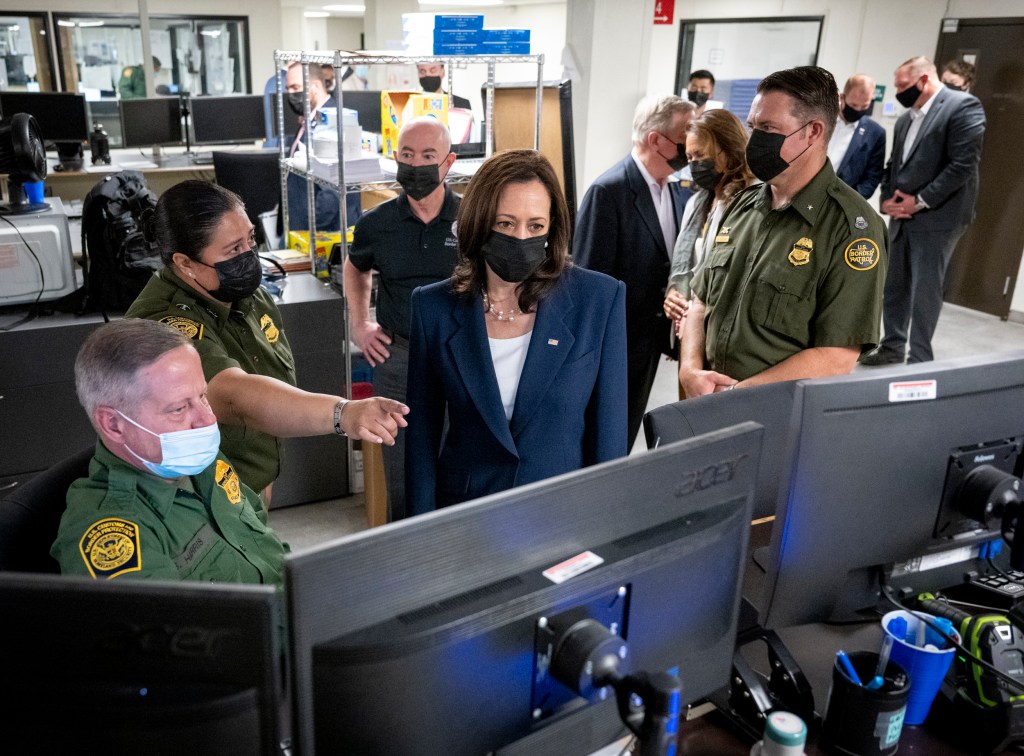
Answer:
[452, 150, 571, 312]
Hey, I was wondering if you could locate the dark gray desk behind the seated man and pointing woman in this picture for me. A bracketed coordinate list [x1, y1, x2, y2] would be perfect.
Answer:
[0, 274, 348, 507]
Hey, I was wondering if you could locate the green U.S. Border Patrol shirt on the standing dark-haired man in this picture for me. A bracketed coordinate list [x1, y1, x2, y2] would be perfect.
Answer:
[693, 161, 889, 381]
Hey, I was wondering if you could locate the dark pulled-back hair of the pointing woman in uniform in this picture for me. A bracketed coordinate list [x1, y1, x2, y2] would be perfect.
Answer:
[148, 179, 246, 265]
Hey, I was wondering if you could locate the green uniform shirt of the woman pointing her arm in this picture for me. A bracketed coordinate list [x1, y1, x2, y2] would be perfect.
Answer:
[125, 267, 295, 491]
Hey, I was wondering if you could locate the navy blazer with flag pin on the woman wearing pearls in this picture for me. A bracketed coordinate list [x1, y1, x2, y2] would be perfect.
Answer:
[403, 266, 628, 514]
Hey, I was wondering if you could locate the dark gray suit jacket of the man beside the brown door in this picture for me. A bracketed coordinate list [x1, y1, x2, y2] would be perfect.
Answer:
[882, 86, 985, 232]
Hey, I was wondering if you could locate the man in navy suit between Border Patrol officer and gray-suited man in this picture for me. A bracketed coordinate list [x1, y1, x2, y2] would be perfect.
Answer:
[828, 74, 886, 200]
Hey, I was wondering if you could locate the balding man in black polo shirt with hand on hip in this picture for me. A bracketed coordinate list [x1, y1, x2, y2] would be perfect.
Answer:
[345, 116, 459, 520]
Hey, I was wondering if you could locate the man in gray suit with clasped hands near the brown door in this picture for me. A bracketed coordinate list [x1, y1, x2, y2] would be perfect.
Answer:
[860, 56, 985, 366]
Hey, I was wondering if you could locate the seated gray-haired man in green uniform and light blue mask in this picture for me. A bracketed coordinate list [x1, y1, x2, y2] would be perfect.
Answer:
[50, 320, 288, 585]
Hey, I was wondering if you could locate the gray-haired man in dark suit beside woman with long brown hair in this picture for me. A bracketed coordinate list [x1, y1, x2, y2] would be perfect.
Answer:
[572, 95, 695, 444]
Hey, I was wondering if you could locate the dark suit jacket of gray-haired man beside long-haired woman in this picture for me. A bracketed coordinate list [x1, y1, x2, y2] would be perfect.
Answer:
[572, 155, 685, 354]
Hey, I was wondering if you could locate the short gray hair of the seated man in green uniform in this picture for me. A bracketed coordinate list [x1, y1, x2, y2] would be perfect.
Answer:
[75, 318, 191, 430]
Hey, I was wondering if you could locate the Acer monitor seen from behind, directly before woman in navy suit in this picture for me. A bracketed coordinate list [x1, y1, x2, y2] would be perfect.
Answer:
[286, 423, 761, 756]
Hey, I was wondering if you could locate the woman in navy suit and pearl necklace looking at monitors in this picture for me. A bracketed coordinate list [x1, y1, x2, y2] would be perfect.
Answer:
[406, 150, 628, 514]
